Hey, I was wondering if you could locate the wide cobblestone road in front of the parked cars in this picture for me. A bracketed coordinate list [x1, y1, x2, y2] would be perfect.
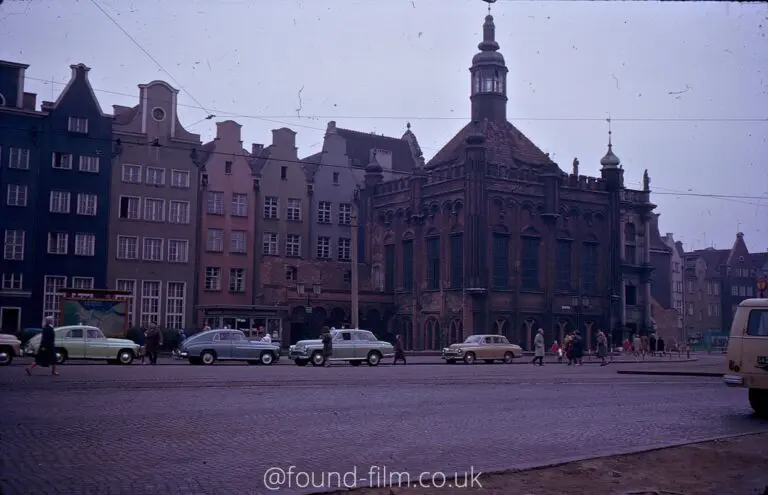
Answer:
[0, 365, 768, 495]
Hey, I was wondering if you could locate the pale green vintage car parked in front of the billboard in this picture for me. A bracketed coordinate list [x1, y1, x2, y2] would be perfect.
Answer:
[26, 325, 139, 364]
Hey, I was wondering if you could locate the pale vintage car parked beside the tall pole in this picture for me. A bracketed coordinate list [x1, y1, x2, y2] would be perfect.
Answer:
[289, 328, 395, 366]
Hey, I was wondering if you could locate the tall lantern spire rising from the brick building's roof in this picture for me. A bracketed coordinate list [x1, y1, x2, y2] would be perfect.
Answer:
[469, 0, 508, 122]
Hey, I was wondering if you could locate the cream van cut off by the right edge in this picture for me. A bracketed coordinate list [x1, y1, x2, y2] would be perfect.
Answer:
[723, 299, 768, 418]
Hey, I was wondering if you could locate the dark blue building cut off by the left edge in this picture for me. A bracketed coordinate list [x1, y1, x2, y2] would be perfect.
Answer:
[0, 60, 45, 333]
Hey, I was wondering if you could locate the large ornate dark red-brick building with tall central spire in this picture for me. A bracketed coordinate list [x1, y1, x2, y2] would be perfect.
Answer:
[360, 11, 655, 349]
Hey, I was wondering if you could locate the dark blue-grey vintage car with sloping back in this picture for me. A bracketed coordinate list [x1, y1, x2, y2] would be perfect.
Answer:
[179, 328, 280, 365]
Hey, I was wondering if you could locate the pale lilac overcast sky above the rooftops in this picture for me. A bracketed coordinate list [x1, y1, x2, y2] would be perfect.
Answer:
[0, 0, 768, 251]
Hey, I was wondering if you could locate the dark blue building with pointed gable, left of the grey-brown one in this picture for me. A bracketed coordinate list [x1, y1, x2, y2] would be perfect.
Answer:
[0, 64, 113, 331]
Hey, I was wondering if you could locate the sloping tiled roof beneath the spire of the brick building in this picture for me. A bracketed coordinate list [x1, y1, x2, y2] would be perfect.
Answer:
[427, 120, 552, 168]
